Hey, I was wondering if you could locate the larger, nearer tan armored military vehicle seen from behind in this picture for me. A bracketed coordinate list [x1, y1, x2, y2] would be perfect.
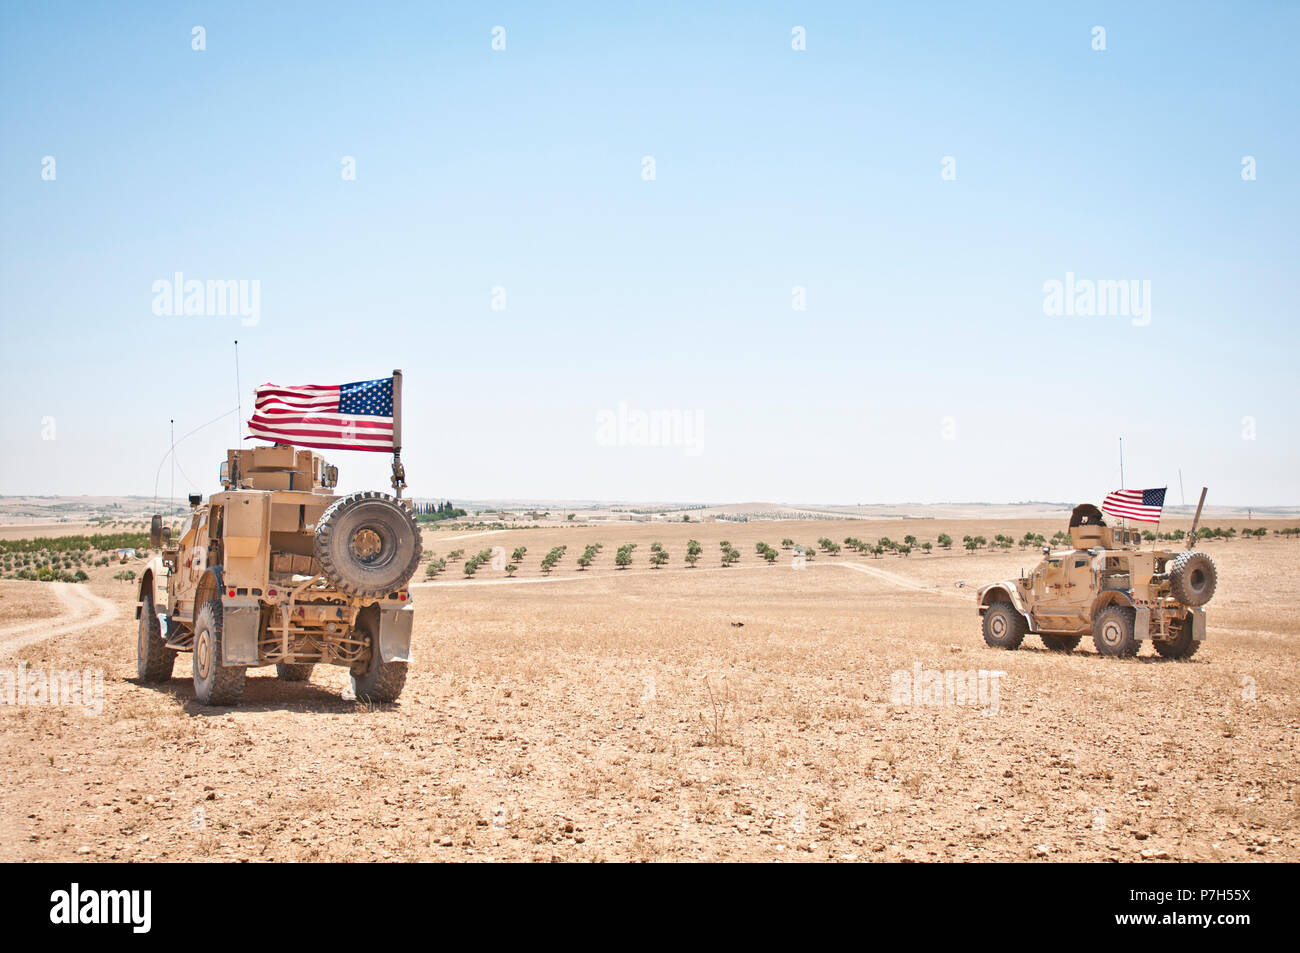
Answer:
[137, 445, 420, 705]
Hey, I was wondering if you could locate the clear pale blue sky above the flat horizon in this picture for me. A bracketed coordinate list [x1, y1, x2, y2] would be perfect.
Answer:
[0, 3, 1300, 504]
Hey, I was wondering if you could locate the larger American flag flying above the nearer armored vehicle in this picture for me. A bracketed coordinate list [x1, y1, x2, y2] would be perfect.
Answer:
[248, 377, 393, 452]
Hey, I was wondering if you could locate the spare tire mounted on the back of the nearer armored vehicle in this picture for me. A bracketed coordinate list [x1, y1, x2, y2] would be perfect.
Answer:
[316, 491, 421, 597]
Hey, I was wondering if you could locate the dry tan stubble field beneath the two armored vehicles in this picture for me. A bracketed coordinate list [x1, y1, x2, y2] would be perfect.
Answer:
[0, 520, 1300, 862]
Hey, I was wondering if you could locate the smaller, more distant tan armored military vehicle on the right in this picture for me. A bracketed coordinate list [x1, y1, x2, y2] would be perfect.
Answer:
[979, 493, 1217, 658]
